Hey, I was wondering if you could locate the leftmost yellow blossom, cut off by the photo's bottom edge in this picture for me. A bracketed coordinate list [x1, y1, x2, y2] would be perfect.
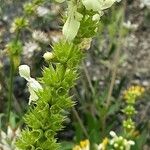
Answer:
[72, 140, 90, 150]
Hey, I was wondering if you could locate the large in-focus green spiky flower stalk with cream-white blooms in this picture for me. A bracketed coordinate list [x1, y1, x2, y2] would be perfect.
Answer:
[16, 0, 120, 150]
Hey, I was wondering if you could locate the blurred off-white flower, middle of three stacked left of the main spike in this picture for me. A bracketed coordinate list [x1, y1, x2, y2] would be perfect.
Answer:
[32, 30, 49, 43]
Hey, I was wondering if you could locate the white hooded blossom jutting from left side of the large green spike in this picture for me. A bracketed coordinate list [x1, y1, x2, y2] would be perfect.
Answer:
[19, 65, 43, 105]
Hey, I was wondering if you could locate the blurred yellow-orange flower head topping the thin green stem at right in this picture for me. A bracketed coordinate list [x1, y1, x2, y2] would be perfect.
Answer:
[124, 85, 145, 104]
